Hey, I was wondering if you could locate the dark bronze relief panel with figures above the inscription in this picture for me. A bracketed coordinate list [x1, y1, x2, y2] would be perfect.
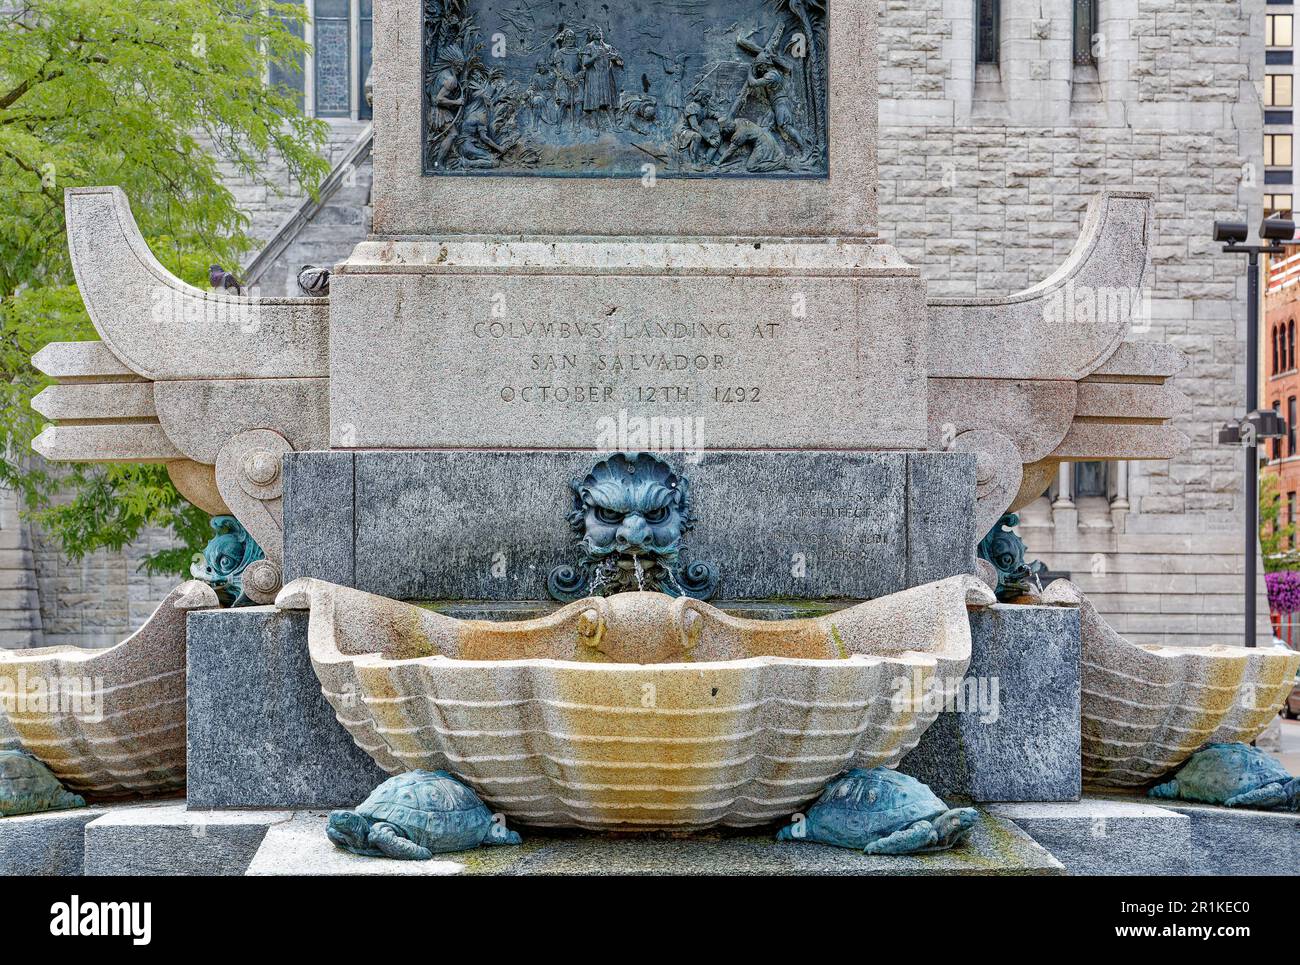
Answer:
[424, 0, 828, 178]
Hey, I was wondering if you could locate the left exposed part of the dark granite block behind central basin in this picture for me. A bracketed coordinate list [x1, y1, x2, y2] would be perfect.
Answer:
[186, 607, 387, 808]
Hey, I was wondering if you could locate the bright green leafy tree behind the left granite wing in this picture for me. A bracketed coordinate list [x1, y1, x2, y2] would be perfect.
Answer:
[0, 0, 329, 572]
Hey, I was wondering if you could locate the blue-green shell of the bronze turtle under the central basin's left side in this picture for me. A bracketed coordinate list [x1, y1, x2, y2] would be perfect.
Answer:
[356, 770, 493, 852]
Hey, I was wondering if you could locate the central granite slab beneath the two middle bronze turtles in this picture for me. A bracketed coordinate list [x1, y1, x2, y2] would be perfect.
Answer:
[247, 812, 1063, 877]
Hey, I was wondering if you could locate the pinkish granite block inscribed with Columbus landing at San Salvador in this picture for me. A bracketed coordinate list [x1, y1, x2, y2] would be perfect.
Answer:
[330, 243, 927, 449]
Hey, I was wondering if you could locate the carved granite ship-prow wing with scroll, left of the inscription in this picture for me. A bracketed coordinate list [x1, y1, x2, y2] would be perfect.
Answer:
[33, 187, 329, 602]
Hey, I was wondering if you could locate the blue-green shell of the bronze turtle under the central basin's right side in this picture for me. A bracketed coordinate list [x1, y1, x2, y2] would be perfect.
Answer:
[807, 767, 948, 848]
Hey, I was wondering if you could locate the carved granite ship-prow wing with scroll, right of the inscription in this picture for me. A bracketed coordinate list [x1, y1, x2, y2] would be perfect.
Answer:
[928, 191, 1188, 533]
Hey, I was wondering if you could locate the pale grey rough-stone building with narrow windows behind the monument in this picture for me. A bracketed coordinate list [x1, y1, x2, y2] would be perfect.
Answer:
[0, 0, 1269, 645]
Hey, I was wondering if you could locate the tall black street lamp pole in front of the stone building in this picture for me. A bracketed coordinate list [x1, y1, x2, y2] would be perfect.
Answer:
[1214, 217, 1296, 646]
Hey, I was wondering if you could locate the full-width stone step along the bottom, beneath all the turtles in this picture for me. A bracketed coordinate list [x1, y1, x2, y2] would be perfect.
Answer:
[0, 796, 1300, 875]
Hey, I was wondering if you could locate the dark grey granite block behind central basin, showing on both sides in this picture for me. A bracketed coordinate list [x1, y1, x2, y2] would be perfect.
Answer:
[180, 602, 1080, 808]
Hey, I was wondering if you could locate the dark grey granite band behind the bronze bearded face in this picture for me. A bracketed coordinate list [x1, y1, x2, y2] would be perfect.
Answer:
[285, 451, 974, 600]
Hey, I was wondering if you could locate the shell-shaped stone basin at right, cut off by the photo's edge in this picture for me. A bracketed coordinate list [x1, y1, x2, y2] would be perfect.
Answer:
[1045, 580, 1300, 787]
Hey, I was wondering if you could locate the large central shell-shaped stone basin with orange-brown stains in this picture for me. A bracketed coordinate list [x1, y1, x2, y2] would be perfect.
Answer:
[276, 576, 995, 830]
